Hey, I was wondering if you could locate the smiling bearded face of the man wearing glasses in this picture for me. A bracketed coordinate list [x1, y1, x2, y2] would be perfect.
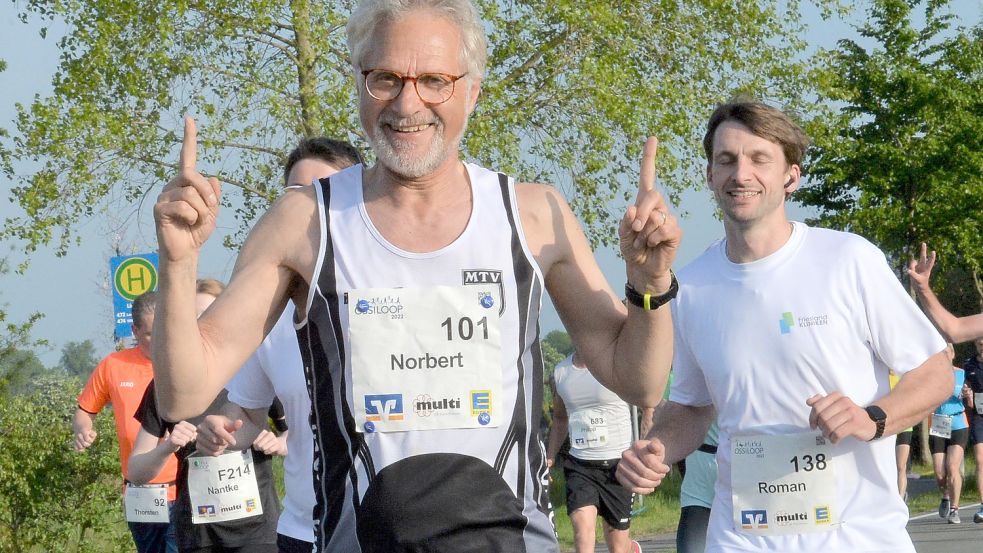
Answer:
[359, 11, 480, 178]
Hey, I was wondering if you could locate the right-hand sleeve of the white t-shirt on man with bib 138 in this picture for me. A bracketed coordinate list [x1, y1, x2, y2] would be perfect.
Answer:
[856, 237, 945, 375]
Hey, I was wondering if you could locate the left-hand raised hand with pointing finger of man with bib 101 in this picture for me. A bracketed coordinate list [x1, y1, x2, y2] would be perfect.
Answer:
[154, 117, 221, 261]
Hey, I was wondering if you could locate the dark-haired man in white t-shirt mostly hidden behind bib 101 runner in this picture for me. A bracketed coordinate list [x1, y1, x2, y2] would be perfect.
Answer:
[198, 137, 362, 553]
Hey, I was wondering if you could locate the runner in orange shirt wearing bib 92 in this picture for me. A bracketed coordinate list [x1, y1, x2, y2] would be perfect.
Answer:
[72, 292, 177, 553]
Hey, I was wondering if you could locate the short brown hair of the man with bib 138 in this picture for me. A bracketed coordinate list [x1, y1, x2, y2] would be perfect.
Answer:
[703, 99, 809, 167]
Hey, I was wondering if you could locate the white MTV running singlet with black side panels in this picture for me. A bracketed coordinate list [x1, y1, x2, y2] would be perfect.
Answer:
[297, 164, 559, 553]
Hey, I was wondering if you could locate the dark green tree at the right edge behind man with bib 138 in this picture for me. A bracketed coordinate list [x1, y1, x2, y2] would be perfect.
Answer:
[797, 0, 983, 288]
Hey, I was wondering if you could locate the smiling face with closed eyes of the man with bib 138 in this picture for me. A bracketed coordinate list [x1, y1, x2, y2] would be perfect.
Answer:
[707, 121, 800, 229]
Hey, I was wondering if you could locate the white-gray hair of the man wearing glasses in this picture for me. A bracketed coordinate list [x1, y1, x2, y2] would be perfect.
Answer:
[346, 0, 488, 79]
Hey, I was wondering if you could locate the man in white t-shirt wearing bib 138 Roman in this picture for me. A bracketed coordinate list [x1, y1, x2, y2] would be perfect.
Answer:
[618, 101, 953, 553]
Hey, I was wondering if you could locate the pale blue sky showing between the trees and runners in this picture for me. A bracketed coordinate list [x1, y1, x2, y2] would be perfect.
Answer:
[0, 0, 983, 365]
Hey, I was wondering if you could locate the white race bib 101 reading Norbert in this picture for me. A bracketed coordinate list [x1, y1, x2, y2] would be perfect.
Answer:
[348, 286, 503, 433]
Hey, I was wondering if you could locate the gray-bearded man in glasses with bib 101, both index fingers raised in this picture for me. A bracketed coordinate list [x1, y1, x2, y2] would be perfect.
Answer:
[154, 0, 681, 553]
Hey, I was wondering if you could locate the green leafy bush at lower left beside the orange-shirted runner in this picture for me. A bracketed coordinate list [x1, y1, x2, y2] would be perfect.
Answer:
[0, 373, 132, 552]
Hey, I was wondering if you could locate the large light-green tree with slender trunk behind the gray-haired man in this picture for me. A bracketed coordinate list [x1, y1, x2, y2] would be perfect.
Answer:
[7, 0, 836, 251]
